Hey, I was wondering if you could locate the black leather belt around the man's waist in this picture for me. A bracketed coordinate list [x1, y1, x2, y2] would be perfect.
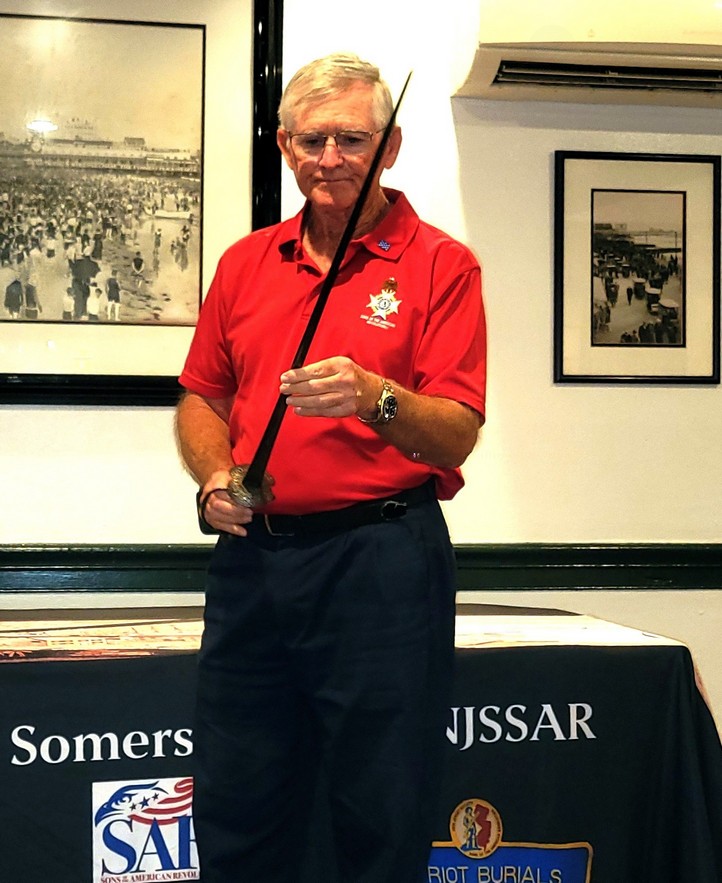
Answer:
[250, 479, 436, 537]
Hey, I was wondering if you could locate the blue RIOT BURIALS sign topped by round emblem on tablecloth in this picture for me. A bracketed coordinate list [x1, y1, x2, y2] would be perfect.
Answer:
[429, 798, 592, 883]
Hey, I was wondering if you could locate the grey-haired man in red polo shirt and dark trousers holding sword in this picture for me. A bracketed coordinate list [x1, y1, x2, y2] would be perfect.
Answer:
[177, 55, 485, 883]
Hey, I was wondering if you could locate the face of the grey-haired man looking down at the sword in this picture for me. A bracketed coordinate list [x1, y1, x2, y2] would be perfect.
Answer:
[277, 83, 401, 212]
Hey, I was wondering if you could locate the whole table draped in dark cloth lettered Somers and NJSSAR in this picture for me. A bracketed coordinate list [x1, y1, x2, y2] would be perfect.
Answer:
[0, 605, 722, 883]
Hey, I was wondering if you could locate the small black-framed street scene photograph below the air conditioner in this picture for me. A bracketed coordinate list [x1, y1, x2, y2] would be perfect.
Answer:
[554, 151, 720, 384]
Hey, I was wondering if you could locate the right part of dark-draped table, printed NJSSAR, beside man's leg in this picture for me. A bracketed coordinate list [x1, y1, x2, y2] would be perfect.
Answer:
[429, 611, 722, 883]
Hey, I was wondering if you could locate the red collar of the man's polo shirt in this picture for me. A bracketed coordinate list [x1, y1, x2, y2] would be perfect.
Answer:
[278, 187, 419, 260]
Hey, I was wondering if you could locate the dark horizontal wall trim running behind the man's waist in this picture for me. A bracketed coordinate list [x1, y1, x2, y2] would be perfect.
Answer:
[0, 543, 722, 593]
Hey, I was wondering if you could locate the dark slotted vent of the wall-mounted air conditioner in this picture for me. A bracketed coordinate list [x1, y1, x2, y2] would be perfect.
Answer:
[493, 59, 722, 94]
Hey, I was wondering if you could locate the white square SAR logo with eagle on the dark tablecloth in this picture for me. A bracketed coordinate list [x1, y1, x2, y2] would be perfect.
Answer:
[93, 778, 200, 883]
